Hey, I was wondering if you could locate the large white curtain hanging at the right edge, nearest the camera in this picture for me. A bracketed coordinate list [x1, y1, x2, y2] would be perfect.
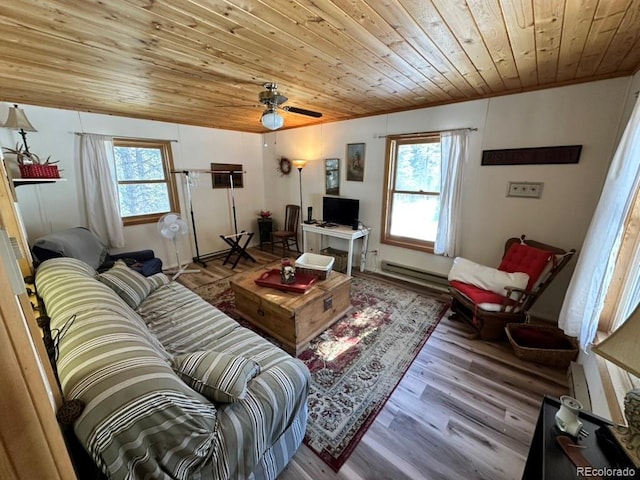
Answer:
[559, 94, 640, 350]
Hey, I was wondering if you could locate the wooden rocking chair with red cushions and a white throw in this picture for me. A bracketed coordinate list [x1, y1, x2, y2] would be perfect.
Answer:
[449, 235, 575, 340]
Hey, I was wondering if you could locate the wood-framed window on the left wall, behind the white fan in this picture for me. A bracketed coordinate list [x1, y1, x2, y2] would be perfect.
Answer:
[113, 138, 178, 225]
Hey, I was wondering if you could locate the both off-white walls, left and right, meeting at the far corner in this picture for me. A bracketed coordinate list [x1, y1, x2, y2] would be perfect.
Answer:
[0, 76, 638, 319]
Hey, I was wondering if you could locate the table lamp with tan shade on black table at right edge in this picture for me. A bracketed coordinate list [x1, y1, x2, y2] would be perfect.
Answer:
[592, 306, 640, 467]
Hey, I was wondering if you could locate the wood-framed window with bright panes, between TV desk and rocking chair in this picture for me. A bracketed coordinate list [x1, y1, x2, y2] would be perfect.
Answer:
[381, 135, 440, 252]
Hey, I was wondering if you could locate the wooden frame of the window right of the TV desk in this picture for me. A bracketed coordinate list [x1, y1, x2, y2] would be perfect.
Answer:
[380, 133, 442, 253]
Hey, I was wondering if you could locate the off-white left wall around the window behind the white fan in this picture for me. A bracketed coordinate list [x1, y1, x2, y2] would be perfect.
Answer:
[0, 104, 264, 265]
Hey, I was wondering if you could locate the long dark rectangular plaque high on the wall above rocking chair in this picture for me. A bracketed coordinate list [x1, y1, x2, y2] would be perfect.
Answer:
[482, 145, 582, 165]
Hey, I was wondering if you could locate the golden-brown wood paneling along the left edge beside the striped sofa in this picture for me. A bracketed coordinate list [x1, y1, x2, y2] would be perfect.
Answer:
[0, 158, 76, 480]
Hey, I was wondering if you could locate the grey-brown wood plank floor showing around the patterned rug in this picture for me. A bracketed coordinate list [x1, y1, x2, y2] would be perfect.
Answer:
[182, 250, 568, 480]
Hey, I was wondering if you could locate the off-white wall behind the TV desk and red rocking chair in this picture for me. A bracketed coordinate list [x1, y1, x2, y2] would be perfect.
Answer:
[264, 77, 631, 320]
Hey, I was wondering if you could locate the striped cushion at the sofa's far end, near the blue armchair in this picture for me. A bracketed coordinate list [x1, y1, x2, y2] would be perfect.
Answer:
[96, 260, 169, 309]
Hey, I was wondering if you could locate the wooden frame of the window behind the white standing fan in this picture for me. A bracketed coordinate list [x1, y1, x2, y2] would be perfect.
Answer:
[113, 137, 179, 227]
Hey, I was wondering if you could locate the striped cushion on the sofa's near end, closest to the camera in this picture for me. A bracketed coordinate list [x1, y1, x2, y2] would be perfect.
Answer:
[173, 350, 260, 403]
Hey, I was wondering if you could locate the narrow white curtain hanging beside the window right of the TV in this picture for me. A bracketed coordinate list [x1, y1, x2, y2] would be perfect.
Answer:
[433, 129, 469, 257]
